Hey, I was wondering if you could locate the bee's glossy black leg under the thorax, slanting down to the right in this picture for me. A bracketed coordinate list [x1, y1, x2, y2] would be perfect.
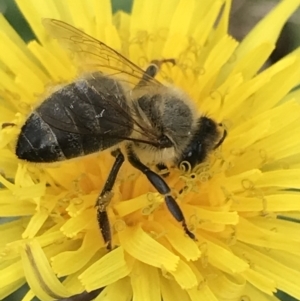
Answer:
[127, 148, 197, 240]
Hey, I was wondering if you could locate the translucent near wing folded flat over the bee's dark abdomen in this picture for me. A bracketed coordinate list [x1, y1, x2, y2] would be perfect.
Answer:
[36, 72, 163, 146]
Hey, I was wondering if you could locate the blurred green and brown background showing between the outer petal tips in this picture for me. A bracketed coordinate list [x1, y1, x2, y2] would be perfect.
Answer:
[0, 0, 300, 301]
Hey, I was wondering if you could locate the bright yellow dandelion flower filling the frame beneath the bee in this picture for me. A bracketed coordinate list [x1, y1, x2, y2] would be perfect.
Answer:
[0, 0, 300, 301]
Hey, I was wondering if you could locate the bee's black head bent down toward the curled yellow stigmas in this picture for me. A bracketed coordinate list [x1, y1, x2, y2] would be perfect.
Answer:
[178, 116, 227, 169]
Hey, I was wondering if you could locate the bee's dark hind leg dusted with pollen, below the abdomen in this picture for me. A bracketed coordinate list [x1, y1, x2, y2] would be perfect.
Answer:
[95, 149, 124, 250]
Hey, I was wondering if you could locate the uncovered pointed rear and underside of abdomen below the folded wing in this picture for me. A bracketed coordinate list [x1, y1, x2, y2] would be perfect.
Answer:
[16, 108, 110, 163]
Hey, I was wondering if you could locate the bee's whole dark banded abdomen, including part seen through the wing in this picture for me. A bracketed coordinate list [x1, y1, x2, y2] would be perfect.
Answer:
[16, 73, 133, 162]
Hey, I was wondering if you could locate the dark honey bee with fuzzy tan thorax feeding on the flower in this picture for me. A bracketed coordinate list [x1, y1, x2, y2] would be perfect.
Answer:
[16, 19, 226, 250]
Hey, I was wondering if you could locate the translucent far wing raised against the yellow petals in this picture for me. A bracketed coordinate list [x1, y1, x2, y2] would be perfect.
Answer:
[42, 19, 162, 89]
